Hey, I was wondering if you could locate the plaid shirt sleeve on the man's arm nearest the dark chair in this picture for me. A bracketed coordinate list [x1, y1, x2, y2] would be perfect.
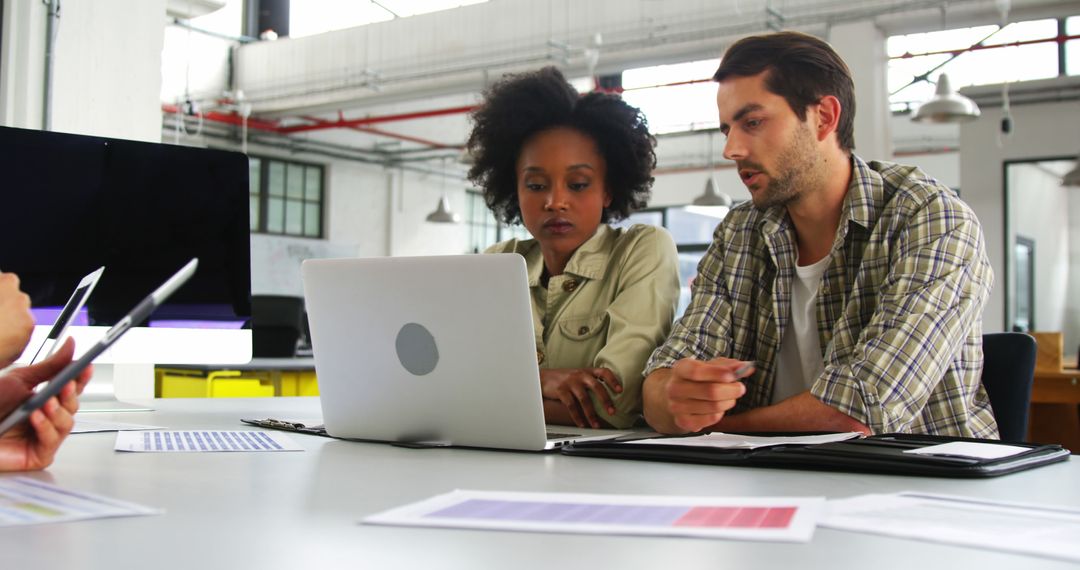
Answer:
[810, 196, 994, 433]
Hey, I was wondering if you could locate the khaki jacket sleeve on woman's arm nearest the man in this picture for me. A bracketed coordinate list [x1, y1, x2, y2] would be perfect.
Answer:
[593, 227, 679, 429]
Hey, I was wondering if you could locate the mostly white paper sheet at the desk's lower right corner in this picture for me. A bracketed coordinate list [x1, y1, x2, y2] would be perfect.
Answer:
[821, 492, 1080, 561]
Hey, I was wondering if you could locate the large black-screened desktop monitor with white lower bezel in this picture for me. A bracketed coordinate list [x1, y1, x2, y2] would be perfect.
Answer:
[0, 127, 251, 363]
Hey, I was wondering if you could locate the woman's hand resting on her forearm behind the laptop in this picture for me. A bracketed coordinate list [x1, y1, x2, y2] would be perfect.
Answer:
[540, 368, 622, 428]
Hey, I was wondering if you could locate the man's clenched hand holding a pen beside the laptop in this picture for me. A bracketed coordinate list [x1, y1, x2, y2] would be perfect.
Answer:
[644, 358, 754, 433]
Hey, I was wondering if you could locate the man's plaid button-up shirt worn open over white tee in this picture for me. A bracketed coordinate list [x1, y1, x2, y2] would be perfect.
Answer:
[645, 155, 998, 437]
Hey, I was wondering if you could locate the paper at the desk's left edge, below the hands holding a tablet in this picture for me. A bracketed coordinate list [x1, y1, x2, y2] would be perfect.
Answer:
[0, 477, 161, 527]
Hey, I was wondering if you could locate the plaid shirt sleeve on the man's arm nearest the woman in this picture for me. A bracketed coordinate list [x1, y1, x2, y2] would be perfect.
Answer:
[644, 223, 731, 377]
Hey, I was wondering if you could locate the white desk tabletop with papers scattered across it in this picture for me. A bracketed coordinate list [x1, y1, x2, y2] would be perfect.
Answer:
[0, 398, 1080, 570]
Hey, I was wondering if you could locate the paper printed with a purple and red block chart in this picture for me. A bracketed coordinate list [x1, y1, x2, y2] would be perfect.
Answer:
[363, 490, 824, 542]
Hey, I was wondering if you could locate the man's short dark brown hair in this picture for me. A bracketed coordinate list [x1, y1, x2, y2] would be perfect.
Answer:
[713, 31, 855, 152]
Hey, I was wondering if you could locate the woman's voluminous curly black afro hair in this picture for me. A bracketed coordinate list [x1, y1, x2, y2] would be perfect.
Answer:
[467, 67, 657, 223]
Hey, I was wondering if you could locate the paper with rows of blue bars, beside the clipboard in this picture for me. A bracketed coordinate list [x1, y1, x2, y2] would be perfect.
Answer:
[114, 430, 303, 453]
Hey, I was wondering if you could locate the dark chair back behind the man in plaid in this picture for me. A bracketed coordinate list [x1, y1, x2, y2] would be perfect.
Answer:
[983, 333, 1036, 442]
